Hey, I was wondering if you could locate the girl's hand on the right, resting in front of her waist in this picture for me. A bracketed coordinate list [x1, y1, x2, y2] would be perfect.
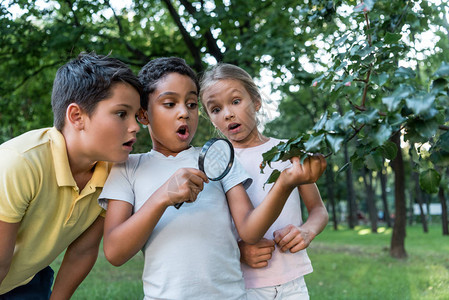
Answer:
[273, 224, 315, 253]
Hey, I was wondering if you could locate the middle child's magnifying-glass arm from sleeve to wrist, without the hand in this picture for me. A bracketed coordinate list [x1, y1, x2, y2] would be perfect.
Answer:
[103, 192, 167, 266]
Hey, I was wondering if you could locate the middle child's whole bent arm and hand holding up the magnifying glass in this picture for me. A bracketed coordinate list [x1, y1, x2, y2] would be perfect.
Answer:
[103, 168, 208, 266]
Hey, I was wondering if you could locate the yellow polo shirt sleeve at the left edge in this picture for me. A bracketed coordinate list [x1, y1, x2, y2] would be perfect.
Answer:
[0, 149, 39, 223]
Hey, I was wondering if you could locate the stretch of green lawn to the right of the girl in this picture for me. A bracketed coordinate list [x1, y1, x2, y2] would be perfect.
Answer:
[305, 226, 449, 300]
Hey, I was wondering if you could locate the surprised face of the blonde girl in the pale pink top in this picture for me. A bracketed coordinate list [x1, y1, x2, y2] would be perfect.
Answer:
[202, 79, 260, 147]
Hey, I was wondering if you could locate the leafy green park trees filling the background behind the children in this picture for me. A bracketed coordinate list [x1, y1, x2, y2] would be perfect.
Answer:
[0, 0, 449, 258]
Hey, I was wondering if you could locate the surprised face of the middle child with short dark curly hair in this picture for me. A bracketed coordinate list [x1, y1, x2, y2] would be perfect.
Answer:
[142, 73, 198, 156]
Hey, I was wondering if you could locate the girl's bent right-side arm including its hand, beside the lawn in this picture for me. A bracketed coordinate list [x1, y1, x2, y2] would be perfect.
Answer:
[273, 184, 329, 253]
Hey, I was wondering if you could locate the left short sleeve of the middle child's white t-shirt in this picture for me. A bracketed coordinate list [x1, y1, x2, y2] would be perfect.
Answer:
[98, 161, 135, 209]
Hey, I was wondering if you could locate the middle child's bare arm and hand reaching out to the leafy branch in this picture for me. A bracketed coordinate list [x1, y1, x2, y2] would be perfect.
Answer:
[226, 155, 326, 244]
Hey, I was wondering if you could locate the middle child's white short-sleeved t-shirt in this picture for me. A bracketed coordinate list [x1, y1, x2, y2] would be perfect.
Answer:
[100, 147, 251, 300]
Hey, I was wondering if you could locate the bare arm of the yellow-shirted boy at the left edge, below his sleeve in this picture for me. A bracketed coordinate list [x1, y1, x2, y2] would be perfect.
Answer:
[0, 221, 20, 285]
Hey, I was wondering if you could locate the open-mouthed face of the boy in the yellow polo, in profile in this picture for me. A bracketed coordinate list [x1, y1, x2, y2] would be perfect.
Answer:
[82, 83, 140, 162]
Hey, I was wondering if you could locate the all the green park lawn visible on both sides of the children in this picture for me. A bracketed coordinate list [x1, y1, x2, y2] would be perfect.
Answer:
[52, 225, 449, 300]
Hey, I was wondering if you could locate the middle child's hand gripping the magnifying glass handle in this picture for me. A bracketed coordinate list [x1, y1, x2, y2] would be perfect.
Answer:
[164, 168, 209, 206]
